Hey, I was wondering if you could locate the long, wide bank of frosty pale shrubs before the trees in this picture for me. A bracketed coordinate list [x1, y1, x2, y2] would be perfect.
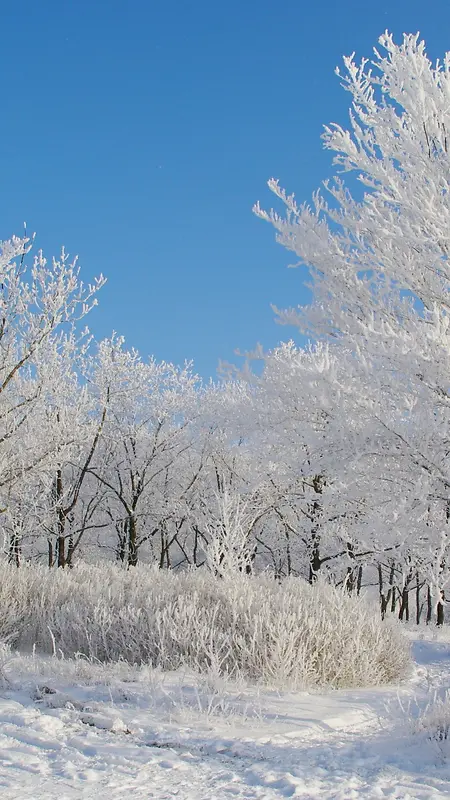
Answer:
[0, 565, 409, 687]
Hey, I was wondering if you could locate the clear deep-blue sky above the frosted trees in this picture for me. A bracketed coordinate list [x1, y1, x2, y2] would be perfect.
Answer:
[0, 0, 450, 376]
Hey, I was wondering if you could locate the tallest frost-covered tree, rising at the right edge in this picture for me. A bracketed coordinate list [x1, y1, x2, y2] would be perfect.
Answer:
[255, 33, 450, 620]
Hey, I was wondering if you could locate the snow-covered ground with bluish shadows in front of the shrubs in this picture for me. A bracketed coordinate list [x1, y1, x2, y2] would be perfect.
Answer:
[0, 632, 450, 800]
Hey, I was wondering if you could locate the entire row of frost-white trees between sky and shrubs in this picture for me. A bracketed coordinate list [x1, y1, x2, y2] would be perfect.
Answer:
[0, 34, 450, 623]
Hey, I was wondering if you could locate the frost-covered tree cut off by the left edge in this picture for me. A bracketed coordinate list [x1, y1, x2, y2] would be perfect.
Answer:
[0, 231, 104, 558]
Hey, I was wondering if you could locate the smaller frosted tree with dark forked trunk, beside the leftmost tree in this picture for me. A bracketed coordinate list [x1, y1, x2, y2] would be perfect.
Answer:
[87, 337, 198, 566]
